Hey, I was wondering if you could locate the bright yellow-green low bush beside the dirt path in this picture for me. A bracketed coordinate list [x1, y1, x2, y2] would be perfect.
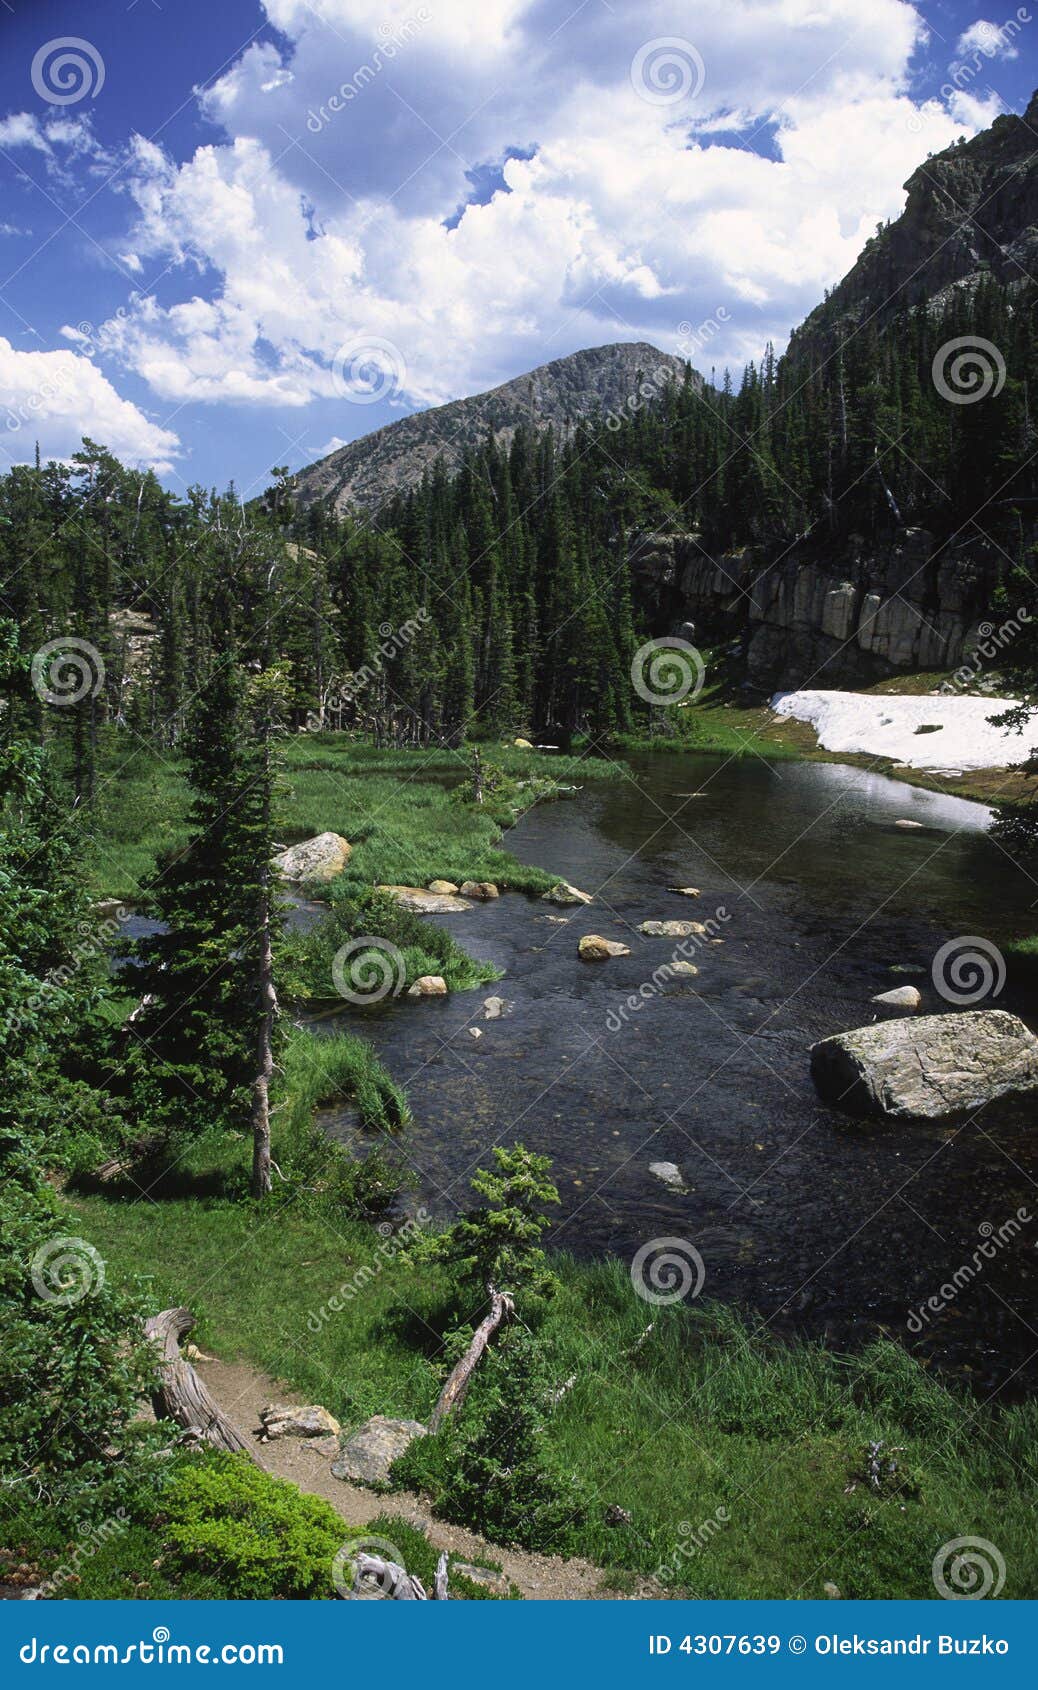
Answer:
[166, 1455, 348, 1600]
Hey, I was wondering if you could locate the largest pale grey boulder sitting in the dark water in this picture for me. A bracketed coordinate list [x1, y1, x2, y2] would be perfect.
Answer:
[811, 1009, 1038, 1120]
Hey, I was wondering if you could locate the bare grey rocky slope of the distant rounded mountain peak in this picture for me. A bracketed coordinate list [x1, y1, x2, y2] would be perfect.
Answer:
[296, 341, 702, 512]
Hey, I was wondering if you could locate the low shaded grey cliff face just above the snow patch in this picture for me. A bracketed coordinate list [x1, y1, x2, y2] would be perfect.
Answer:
[632, 529, 999, 690]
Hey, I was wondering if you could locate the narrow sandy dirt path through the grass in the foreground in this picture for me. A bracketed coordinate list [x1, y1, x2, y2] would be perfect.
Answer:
[194, 1359, 666, 1602]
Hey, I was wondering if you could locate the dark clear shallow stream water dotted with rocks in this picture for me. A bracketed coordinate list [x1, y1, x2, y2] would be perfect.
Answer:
[321, 757, 1038, 1389]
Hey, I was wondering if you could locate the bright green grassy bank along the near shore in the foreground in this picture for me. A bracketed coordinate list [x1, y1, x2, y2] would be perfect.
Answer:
[74, 1068, 1038, 1597]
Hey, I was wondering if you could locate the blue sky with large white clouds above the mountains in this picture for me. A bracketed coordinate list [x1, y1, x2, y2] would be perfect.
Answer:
[0, 0, 1038, 492]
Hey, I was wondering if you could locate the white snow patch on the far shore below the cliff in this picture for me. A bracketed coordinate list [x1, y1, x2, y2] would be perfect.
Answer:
[771, 691, 1038, 772]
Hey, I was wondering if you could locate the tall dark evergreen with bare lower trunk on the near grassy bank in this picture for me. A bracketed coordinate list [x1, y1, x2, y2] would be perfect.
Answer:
[125, 657, 284, 1197]
